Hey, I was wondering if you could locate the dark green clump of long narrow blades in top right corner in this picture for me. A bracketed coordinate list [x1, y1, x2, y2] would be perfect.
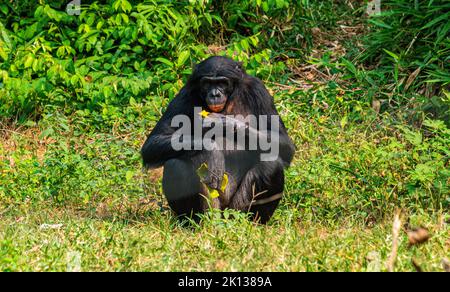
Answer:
[361, 0, 450, 101]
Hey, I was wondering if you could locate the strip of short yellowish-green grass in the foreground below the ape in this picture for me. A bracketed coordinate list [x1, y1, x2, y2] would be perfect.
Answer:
[0, 201, 449, 271]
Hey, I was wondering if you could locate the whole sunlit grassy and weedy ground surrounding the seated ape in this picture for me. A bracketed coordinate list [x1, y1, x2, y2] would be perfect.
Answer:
[0, 88, 450, 271]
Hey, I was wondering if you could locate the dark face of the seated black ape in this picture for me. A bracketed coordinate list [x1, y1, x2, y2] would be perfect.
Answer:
[200, 76, 233, 113]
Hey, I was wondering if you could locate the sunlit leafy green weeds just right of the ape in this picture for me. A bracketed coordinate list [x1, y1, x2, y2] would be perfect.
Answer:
[276, 87, 450, 224]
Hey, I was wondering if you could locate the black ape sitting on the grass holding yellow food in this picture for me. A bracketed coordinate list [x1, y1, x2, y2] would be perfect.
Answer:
[141, 56, 294, 223]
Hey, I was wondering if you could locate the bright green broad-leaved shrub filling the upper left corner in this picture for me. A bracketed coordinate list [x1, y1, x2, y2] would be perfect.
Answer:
[0, 0, 304, 119]
